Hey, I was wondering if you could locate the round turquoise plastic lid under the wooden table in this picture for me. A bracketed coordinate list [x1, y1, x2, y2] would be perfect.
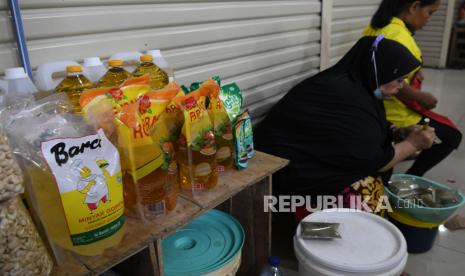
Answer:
[162, 210, 244, 276]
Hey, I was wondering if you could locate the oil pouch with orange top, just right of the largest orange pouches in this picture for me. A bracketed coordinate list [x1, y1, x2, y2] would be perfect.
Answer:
[176, 81, 219, 195]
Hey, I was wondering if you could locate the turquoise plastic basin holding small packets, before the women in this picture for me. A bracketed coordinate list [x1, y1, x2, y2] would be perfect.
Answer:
[384, 174, 465, 223]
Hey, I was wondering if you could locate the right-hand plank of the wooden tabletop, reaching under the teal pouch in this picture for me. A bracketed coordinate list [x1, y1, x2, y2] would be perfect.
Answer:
[181, 151, 289, 208]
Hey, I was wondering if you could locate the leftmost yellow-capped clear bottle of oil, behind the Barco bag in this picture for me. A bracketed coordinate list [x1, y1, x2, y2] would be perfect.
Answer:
[55, 65, 94, 114]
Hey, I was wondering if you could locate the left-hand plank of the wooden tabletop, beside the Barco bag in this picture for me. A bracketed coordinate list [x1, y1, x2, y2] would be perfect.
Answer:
[78, 197, 200, 274]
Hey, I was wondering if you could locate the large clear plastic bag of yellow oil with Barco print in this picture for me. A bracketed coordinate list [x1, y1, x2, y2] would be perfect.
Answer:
[2, 94, 125, 263]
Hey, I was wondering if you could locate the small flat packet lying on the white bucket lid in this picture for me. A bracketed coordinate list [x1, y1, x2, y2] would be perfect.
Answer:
[300, 221, 341, 239]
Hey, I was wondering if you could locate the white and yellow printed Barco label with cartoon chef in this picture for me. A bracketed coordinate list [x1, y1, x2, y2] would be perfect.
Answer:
[41, 129, 124, 246]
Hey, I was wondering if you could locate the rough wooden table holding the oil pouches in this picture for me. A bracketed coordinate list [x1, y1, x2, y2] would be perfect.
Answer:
[52, 152, 288, 275]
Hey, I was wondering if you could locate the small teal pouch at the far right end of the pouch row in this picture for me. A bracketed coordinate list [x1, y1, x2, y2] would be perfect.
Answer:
[233, 111, 254, 170]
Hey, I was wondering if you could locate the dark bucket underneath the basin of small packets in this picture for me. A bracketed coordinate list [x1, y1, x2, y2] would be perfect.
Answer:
[388, 210, 440, 253]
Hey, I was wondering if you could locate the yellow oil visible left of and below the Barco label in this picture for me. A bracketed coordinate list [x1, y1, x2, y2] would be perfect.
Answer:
[27, 165, 125, 256]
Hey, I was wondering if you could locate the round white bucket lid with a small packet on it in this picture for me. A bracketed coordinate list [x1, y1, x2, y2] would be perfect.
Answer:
[296, 209, 407, 274]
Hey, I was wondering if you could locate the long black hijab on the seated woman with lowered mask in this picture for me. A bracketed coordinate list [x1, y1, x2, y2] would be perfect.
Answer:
[254, 37, 420, 195]
